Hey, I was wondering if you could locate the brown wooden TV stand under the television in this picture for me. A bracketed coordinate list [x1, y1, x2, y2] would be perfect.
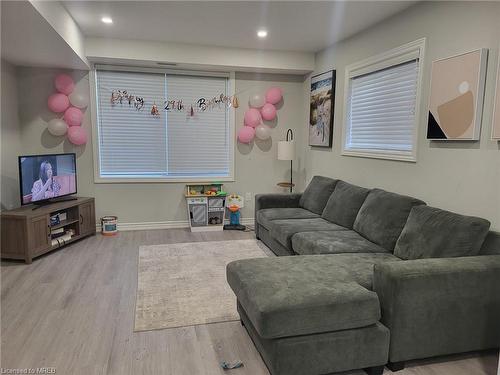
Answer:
[1, 197, 96, 263]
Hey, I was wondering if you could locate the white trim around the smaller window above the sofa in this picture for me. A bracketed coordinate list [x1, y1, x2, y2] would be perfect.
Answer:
[341, 38, 426, 162]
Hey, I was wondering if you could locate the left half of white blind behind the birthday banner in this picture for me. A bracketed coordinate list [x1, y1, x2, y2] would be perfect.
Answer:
[97, 71, 167, 178]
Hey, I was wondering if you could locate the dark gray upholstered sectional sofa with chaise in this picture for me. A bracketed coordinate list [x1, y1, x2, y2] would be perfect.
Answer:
[227, 176, 500, 375]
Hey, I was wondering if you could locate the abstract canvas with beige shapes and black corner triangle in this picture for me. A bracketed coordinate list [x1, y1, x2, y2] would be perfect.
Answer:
[427, 49, 488, 140]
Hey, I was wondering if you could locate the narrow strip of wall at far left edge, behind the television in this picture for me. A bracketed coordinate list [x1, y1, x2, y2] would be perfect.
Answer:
[0, 60, 21, 209]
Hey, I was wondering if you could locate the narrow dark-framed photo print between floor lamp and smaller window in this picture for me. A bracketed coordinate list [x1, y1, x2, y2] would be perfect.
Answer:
[309, 70, 335, 147]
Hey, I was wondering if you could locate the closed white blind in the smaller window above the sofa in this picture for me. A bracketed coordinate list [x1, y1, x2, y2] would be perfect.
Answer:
[344, 59, 419, 156]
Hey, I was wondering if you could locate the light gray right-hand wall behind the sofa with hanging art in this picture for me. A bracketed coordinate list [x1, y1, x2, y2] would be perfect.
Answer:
[301, 2, 500, 230]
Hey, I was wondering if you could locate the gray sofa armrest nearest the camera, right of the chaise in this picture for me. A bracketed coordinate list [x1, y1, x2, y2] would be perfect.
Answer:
[373, 255, 500, 362]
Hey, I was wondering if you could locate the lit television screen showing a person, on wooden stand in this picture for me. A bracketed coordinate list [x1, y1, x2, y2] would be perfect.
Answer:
[19, 154, 76, 205]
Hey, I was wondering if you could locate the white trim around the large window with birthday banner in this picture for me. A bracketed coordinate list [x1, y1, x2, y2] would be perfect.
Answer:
[89, 65, 236, 184]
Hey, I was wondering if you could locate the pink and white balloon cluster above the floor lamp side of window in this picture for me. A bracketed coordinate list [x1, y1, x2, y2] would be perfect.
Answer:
[238, 87, 283, 143]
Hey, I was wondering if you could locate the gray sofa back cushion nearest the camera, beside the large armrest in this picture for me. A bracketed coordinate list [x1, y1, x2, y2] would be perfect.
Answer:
[394, 206, 490, 259]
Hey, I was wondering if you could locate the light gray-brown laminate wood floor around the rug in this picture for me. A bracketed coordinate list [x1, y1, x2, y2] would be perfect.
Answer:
[1, 229, 498, 375]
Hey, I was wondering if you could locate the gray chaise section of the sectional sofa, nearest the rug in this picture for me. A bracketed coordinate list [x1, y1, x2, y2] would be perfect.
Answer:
[227, 255, 389, 375]
